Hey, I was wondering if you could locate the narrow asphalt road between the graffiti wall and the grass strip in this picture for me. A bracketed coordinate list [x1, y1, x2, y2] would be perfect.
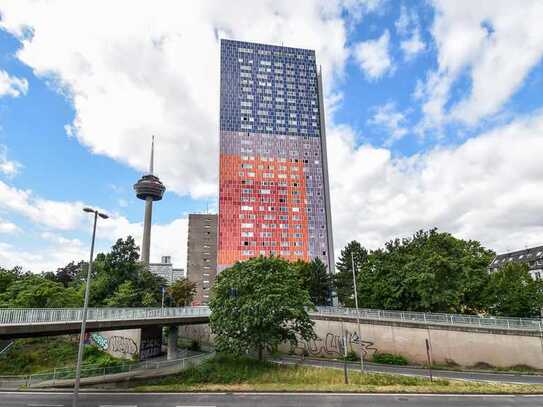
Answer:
[278, 357, 543, 384]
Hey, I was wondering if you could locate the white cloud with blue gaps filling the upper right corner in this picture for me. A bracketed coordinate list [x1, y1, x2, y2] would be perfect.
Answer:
[422, 0, 543, 130]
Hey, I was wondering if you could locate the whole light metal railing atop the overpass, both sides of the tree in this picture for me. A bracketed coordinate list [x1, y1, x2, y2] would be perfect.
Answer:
[0, 307, 543, 333]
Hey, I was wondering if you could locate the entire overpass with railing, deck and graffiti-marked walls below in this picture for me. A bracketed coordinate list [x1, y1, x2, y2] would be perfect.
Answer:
[0, 307, 543, 369]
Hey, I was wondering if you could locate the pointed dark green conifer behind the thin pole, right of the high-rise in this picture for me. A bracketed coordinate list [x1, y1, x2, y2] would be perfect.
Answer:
[334, 240, 368, 307]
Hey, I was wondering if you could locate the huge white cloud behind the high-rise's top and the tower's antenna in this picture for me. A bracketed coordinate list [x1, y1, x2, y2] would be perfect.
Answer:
[0, 0, 366, 197]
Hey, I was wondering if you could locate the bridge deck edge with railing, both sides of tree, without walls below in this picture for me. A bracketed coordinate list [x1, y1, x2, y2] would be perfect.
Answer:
[0, 307, 543, 339]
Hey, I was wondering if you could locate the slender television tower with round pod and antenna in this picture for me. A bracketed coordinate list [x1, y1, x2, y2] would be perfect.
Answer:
[134, 136, 166, 266]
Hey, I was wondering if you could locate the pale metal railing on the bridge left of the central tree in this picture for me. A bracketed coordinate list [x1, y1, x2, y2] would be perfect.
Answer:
[0, 307, 210, 325]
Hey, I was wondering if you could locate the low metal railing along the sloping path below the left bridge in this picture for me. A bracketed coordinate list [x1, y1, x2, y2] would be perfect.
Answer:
[0, 352, 215, 389]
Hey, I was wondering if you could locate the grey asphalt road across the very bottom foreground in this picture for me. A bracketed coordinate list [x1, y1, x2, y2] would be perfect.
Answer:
[0, 392, 543, 407]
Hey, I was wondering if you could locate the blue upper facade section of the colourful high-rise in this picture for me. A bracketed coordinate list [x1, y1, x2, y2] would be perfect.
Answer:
[220, 40, 321, 137]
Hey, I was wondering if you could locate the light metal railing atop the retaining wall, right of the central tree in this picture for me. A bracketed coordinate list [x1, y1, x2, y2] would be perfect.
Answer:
[310, 307, 543, 332]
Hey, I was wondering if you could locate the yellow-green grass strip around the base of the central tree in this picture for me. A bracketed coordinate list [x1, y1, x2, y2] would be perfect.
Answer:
[131, 355, 543, 393]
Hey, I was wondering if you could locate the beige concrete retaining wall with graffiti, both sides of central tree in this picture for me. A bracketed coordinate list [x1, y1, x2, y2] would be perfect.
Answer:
[179, 319, 543, 369]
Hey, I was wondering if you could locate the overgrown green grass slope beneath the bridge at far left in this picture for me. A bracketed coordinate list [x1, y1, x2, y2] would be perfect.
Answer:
[0, 336, 129, 375]
